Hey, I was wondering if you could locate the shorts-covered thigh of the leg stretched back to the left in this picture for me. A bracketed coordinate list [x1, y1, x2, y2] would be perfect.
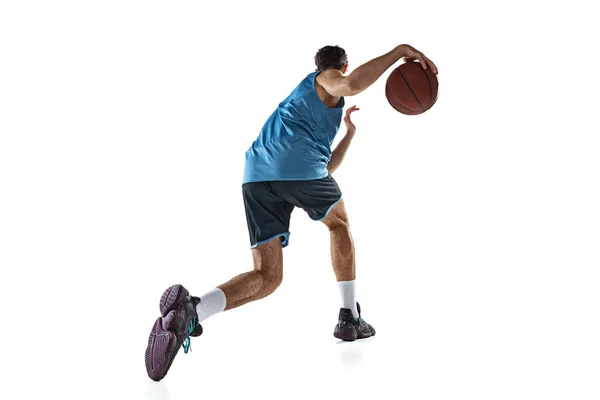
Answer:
[242, 182, 294, 248]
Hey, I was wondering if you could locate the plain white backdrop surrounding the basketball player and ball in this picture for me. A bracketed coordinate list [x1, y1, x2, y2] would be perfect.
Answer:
[0, 0, 600, 400]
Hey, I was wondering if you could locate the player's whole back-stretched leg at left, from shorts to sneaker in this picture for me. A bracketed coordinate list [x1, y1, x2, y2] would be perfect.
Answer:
[146, 182, 294, 381]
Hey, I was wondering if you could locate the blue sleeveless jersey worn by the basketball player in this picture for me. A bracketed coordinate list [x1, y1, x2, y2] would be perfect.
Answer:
[243, 71, 344, 183]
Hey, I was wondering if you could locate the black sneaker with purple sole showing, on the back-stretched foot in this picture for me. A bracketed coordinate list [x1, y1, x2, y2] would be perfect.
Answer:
[146, 285, 202, 381]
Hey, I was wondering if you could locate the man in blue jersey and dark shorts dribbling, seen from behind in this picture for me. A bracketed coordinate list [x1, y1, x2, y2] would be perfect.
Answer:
[146, 45, 437, 381]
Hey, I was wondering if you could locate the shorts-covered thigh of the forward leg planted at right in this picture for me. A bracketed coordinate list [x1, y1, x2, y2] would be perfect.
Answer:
[274, 175, 342, 221]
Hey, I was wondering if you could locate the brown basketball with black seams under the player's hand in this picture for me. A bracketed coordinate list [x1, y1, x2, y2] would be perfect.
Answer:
[385, 61, 438, 115]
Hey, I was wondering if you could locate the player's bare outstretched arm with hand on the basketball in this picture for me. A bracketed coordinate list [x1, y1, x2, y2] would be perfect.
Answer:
[317, 44, 437, 97]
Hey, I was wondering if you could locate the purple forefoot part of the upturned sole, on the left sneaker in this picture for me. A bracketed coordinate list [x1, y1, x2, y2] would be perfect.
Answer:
[145, 317, 180, 382]
